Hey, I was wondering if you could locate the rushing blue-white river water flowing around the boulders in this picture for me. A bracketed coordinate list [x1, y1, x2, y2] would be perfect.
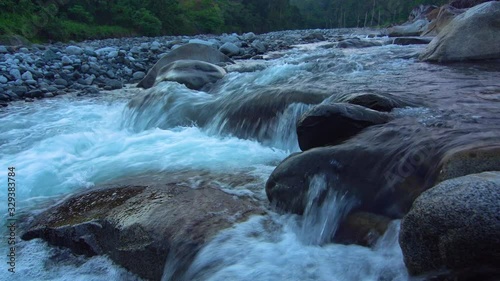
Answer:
[0, 29, 500, 280]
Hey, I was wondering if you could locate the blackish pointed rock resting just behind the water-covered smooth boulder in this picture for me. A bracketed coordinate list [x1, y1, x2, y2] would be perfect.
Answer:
[297, 103, 389, 151]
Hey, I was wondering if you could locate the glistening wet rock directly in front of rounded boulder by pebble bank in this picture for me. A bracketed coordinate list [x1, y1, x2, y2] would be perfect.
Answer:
[154, 60, 226, 90]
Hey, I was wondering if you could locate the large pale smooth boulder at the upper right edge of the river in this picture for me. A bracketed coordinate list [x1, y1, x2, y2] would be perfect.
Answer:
[420, 1, 500, 62]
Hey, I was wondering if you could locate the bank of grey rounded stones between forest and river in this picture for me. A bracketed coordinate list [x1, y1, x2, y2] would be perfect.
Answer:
[0, 29, 386, 106]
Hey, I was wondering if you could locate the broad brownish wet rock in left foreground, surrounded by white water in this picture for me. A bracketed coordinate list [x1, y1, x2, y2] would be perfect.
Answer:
[22, 173, 263, 280]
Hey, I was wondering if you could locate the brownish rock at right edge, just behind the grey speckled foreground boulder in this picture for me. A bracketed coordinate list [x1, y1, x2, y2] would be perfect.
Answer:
[437, 146, 500, 182]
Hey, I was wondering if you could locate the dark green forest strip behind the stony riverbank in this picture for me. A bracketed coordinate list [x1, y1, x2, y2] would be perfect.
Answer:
[0, 0, 448, 42]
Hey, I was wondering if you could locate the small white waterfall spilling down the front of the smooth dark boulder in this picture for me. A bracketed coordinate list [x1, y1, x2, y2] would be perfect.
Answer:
[300, 175, 356, 245]
